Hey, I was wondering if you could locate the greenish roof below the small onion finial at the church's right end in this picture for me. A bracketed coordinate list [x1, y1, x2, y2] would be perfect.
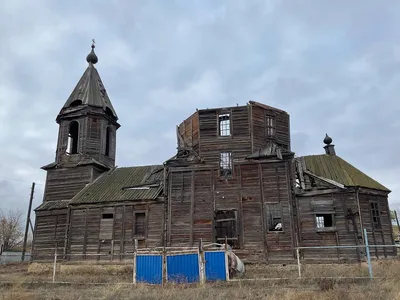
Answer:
[302, 154, 390, 192]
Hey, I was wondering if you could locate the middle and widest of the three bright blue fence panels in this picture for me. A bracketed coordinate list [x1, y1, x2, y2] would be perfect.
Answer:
[167, 253, 199, 283]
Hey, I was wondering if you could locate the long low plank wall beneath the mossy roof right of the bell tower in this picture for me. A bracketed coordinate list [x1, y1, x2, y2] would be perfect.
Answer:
[67, 203, 165, 259]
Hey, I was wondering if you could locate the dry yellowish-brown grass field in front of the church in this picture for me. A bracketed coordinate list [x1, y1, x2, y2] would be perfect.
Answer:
[0, 260, 400, 300]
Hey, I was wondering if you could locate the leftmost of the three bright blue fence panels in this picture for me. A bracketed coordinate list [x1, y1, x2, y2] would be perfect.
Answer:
[136, 255, 162, 284]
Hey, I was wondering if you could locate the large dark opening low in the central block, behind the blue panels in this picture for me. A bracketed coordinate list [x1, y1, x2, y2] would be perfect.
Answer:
[215, 210, 239, 248]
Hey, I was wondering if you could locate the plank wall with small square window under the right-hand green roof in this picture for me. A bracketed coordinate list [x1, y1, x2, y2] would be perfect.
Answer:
[297, 190, 362, 262]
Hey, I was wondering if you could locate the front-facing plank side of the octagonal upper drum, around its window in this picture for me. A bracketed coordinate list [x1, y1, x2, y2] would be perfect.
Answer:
[199, 106, 251, 166]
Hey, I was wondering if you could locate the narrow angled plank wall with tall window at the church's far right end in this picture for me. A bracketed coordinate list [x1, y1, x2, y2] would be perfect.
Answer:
[358, 189, 396, 258]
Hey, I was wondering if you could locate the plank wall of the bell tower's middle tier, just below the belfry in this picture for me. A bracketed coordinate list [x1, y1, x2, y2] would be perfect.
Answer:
[44, 166, 93, 201]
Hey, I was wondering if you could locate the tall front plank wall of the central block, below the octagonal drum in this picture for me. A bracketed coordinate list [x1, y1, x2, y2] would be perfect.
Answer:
[167, 161, 293, 262]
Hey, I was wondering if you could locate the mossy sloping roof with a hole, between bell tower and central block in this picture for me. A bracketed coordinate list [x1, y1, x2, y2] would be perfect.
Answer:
[70, 165, 164, 204]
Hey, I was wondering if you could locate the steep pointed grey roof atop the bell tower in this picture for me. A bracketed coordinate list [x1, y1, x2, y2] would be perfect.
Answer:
[60, 63, 118, 120]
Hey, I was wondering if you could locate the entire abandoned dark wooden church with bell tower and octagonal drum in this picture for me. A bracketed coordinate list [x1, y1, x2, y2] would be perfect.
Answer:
[32, 46, 396, 263]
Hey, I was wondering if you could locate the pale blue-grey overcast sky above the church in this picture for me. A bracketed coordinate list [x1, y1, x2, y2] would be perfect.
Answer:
[0, 0, 400, 216]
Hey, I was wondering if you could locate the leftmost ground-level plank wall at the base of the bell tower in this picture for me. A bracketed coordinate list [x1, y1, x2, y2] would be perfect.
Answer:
[32, 209, 67, 260]
